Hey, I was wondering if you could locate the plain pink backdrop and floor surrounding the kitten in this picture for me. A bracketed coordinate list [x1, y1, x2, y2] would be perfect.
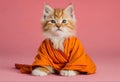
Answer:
[0, 0, 120, 82]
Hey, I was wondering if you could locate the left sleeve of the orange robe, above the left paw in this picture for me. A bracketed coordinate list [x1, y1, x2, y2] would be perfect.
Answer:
[32, 41, 51, 67]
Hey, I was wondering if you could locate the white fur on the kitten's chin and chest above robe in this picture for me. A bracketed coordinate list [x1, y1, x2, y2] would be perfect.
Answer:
[43, 27, 75, 52]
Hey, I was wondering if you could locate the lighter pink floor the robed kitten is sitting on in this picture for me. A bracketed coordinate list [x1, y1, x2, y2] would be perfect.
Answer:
[0, 50, 120, 82]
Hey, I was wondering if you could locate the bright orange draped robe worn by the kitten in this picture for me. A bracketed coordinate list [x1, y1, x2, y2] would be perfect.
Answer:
[15, 37, 96, 74]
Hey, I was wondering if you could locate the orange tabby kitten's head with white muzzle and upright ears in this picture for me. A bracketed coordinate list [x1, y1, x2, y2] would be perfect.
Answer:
[42, 4, 75, 38]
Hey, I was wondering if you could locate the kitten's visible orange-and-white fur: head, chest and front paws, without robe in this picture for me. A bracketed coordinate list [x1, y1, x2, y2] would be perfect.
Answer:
[32, 4, 78, 76]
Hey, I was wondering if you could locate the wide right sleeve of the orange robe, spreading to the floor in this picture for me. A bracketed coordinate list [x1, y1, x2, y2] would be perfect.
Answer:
[63, 39, 96, 74]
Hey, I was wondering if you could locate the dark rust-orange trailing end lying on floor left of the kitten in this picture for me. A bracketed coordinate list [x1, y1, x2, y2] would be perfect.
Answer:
[15, 64, 32, 74]
